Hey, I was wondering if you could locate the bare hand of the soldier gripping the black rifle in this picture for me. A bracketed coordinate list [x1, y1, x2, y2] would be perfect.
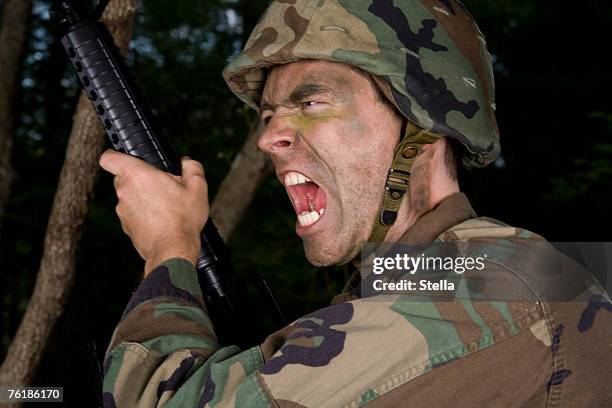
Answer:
[100, 150, 209, 276]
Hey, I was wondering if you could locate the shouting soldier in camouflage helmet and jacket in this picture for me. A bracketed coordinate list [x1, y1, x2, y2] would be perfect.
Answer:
[100, 0, 612, 407]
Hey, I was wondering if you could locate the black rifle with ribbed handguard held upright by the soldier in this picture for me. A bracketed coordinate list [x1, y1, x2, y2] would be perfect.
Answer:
[52, 0, 285, 349]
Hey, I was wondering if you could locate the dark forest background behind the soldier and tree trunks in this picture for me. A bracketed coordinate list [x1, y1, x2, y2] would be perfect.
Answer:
[0, 0, 612, 407]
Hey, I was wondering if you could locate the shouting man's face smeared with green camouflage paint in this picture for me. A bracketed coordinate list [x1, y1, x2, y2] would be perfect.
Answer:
[259, 60, 402, 266]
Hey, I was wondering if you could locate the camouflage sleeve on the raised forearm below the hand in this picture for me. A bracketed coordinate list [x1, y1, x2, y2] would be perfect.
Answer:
[103, 258, 270, 408]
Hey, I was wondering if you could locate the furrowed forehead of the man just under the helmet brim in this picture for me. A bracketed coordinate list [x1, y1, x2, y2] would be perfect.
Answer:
[262, 60, 369, 103]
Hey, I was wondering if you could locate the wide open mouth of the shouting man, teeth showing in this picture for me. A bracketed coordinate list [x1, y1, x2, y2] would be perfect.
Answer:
[283, 171, 327, 227]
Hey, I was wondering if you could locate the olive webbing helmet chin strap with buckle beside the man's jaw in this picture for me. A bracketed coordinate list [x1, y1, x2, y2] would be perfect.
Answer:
[368, 121, 442, 242]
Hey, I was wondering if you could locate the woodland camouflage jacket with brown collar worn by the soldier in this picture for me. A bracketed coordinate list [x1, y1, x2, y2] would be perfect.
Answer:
[103, 194, 612, 408]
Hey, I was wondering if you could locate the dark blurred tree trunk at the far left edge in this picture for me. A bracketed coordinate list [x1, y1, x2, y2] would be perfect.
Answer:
[0, 0, 32, 225]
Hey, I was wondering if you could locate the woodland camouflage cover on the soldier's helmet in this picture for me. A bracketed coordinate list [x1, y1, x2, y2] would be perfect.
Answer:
[223, 0, 500, 166]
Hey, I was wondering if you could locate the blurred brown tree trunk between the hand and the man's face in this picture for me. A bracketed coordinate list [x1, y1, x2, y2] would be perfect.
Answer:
[210, 120, 272, 241]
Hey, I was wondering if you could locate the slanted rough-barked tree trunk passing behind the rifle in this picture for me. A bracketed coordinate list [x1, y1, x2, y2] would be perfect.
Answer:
[0, 0, 137, 392]
